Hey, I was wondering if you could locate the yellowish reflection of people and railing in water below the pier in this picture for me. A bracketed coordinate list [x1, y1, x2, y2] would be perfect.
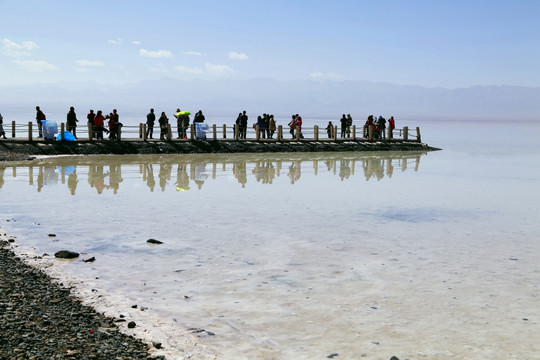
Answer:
[0, 152, 426, 195]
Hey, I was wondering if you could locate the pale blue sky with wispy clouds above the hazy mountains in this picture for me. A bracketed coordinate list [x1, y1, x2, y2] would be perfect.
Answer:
[0, 0, 540, 88]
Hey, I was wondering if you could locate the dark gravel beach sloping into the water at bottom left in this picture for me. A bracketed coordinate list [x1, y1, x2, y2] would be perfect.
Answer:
[0, 240, 165, 360]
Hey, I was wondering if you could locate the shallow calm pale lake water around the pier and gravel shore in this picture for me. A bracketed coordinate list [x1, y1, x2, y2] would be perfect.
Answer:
[0, 122, 540, 359]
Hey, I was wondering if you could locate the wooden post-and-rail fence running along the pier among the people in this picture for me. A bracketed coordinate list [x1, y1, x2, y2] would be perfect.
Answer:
[3, 121, 421, 142]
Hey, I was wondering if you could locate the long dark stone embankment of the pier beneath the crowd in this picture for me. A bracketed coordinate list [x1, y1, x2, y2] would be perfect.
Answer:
[0, 140, 440, 161]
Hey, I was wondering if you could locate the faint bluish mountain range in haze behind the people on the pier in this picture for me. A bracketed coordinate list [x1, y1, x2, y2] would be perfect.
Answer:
[0, 78, 540, 121]
